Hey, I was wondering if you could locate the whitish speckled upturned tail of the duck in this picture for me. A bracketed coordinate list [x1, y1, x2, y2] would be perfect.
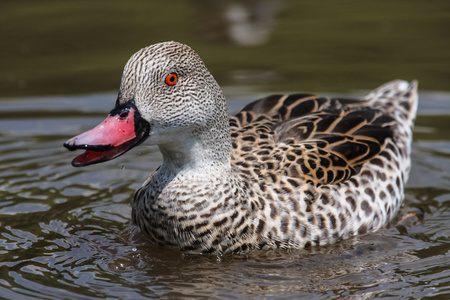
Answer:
[365, 80, 418, 127]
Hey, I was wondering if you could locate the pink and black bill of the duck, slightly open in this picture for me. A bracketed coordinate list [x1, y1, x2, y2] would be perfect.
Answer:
[64, 100, 150, 167]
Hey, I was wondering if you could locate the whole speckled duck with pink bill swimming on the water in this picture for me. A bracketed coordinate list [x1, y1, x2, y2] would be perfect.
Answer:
[64, 41, 418, 255]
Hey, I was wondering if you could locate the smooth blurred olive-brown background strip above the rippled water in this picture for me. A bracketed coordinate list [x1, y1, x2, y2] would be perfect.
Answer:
[0, 0, 450, 97]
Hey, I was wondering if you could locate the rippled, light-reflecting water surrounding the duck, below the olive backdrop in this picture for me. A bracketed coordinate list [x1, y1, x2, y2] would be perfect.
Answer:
[0, 93, 450, 299]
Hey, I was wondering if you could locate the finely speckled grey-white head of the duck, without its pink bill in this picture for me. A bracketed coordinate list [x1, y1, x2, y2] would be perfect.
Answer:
[118, 42, 231, 170]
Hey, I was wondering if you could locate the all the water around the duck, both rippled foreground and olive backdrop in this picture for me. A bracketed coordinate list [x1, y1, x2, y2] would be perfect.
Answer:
[0, 0, 450, 300]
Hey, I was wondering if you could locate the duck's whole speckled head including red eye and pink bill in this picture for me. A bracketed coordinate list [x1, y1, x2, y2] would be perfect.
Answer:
[64, 42, 228, 167]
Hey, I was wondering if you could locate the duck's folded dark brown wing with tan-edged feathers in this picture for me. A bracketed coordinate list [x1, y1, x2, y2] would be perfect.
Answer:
[230, 94, 395, 186]
